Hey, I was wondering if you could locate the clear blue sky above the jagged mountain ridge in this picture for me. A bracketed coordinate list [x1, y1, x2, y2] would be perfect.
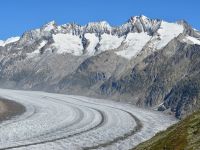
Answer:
[0, 0, 200, 40]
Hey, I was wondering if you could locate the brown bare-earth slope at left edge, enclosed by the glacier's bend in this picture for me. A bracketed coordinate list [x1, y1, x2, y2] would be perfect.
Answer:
[0, 98, 25, 123]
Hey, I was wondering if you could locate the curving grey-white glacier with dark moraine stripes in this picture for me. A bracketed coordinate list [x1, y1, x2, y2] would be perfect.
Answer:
[0, 89, 177, 150]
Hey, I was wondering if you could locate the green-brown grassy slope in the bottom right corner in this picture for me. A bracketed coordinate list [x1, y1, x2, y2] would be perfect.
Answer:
[134, 111, 200, 150]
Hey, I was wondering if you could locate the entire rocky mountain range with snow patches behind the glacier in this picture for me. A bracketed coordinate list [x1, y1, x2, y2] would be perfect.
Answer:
[0, 16, 200, 118]
